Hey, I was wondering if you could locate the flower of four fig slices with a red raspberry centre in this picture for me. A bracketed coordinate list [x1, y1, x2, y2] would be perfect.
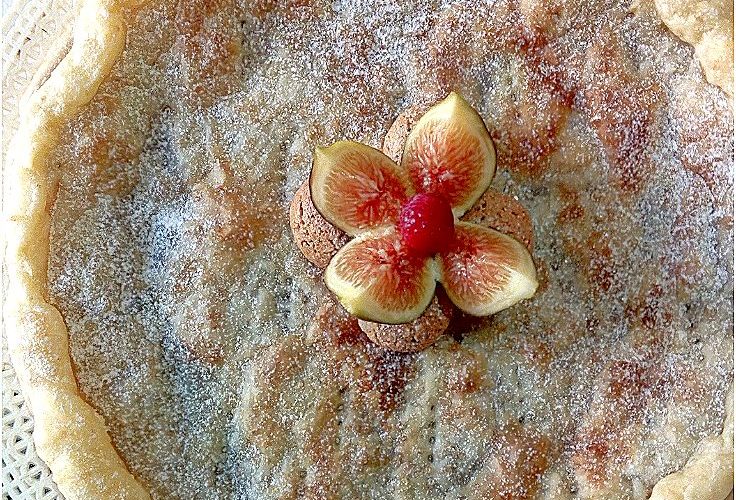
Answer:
[310, 93, 537, 328]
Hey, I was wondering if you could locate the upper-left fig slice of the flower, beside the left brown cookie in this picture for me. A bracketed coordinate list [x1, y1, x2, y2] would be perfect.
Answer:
[309, 141, 413, 236]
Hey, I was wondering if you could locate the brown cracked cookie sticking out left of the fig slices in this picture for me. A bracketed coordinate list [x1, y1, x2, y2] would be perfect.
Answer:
[289, 181, 350, 269]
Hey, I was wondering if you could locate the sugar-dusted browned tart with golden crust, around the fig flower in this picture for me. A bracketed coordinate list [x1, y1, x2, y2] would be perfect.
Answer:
[6, 0, 734, 500]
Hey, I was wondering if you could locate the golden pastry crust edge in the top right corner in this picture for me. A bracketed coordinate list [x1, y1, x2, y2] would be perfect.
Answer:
[654, 0, 733, 96]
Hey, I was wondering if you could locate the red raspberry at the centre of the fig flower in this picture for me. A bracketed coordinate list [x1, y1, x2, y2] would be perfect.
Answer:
[399, 193, 455, 256]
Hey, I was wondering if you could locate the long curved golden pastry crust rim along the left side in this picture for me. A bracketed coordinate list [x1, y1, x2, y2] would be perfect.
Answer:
[5, 0, 150, 499]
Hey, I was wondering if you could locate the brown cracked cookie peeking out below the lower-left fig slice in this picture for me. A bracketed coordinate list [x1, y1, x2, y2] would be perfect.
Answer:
[358, 294, 454, 352]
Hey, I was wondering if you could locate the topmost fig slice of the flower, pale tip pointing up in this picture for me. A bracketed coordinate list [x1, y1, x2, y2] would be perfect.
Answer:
[401, 92, 496, 217]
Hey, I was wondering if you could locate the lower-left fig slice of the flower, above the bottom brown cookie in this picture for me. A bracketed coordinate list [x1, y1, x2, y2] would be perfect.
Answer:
[325, 227, 436, 324]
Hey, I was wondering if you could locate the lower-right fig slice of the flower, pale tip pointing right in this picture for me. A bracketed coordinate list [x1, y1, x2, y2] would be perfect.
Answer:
[437, 222, 537, 316]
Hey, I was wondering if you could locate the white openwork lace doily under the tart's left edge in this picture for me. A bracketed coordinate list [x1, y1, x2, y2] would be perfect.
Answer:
[0, 0, 72, 500]
